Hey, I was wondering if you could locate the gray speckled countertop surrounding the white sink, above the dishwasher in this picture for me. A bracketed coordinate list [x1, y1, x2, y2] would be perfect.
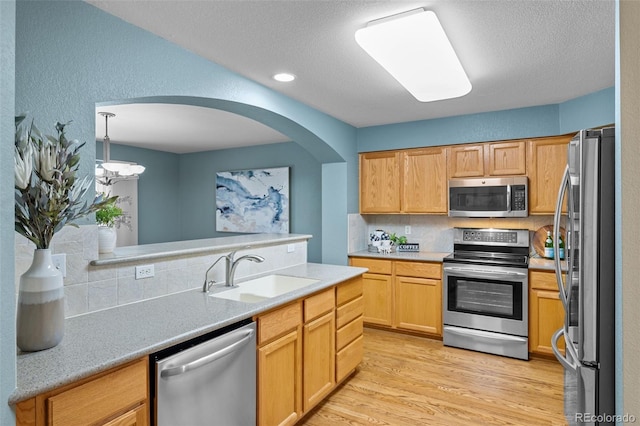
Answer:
[9, 263, 367, 404]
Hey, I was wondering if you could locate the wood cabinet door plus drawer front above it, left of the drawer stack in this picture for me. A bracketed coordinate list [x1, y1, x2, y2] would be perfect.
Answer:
[302, 287, 336, 412]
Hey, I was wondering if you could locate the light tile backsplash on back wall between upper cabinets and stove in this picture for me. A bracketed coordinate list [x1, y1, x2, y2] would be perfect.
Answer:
[349, 214, 553, 252]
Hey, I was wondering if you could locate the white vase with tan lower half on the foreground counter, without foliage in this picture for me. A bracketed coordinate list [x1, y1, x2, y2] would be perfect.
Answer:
[16, 249, 64, 352]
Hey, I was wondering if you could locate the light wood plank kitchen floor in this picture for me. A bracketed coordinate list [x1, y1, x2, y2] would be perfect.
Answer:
[300, 328, 566, 426]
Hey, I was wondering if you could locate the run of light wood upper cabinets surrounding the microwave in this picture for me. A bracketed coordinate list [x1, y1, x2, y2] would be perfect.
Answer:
[360, 135, 572, 215]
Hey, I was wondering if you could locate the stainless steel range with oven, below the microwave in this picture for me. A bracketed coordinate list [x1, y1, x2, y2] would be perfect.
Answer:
[442, 228, 529, 359]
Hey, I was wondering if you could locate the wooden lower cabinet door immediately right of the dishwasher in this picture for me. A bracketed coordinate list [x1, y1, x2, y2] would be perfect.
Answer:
[258, 328, 302, 426]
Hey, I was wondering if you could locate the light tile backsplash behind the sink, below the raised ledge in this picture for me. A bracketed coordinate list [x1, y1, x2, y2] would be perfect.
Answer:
[15, 225, 307, 317]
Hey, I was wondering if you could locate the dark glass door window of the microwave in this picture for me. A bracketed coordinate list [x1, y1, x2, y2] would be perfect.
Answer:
[449, 186, 509, 212]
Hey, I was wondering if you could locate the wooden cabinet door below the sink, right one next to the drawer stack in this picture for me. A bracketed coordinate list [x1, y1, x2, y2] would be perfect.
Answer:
[302, 310, 336, 412]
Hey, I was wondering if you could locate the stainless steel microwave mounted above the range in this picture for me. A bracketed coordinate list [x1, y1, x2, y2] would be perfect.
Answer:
[449, 176, 529, 217]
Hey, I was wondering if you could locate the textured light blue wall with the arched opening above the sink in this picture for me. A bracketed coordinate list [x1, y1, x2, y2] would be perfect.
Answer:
[15, 1, 358, 263]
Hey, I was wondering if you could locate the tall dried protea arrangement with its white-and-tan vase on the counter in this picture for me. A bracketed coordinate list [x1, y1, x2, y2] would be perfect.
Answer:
[14, 115, 114, 351]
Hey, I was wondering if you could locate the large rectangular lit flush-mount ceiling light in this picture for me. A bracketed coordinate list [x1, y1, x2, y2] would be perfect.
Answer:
[356, 9, 471, 102]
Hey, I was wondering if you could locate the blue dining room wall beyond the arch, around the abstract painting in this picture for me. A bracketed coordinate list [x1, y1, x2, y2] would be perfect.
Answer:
[96, 141, 322, 262]
